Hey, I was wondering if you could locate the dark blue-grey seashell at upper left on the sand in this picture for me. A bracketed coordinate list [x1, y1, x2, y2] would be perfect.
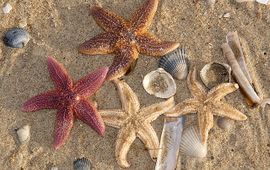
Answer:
[4, 28, 30, 48]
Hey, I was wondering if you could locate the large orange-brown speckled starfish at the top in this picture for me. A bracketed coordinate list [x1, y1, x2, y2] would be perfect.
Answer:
[79, 0, 179, 80]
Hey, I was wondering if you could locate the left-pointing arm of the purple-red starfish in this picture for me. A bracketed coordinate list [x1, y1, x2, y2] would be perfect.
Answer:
[22, 91, 60, 112]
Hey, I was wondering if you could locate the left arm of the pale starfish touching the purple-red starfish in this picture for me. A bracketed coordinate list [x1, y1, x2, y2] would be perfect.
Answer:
[98, 109, 125, 128]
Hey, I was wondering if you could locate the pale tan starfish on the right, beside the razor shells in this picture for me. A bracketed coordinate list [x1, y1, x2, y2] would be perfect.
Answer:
[166, 68, 247, 144]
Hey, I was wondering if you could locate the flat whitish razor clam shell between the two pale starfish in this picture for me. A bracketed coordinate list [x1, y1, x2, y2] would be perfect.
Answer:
[155, 117, 185, 170]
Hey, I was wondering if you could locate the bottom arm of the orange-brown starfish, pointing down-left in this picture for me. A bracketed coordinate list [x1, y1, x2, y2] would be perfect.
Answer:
[107, 45, 139, 80]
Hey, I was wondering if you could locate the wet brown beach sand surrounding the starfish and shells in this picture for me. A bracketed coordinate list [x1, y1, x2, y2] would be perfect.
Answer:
[0, 0, 270, 170]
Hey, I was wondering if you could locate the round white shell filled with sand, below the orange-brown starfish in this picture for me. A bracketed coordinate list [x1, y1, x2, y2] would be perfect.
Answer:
[143, 68, 176, 98]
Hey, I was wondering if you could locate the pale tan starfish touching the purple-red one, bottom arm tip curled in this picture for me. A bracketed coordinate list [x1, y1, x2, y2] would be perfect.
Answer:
[99, 79, 174, 168]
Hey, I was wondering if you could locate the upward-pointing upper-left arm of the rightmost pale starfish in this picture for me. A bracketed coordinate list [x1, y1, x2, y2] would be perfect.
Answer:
[187, 67, 206, 99]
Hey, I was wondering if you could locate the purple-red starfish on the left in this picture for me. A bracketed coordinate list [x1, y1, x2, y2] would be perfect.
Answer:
[22, 57, 108, 149]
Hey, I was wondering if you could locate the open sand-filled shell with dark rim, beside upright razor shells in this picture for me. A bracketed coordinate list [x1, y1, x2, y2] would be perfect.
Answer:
[200, 62, 231, 89]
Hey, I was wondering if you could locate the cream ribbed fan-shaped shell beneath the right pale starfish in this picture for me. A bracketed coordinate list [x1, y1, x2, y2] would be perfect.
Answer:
[180, 126, 207, 158]
